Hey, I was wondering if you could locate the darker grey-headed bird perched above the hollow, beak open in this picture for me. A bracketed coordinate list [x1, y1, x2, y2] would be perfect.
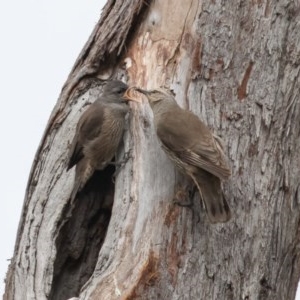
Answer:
[67, 80, 137, 201]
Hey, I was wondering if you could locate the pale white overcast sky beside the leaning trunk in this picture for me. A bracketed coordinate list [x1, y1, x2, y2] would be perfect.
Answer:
[0, 0, 300, 300]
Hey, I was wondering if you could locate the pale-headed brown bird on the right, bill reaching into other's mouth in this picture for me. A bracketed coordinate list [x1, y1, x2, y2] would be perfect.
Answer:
[133, 87, 231, 223]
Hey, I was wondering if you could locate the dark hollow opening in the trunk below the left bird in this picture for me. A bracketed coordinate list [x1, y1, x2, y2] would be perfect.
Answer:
[48, 166, 115, 300]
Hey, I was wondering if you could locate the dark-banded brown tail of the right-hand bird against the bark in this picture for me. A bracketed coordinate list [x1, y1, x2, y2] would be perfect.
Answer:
[191, 170, 231, 223]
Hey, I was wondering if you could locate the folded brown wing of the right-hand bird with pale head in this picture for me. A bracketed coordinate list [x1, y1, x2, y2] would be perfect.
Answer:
[157, 108, 231, 179]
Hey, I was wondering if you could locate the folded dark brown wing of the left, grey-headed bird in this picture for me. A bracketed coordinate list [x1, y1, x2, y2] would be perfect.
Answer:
[67, 103, 103, 170]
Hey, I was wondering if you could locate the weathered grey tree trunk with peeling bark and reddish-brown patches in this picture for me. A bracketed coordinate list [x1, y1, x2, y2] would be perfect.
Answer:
[4, 0, 300, 300]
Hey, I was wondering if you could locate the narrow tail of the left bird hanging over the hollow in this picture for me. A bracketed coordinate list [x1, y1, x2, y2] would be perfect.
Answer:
[71, 159, 95, 203]
